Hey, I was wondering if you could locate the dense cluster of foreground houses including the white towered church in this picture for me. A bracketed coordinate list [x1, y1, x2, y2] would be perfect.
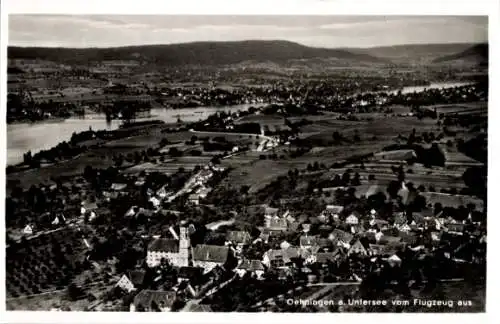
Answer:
[112, 200, 486, 311]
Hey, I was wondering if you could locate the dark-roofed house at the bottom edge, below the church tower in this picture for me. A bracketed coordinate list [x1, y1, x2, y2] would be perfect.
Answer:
[130, 290, 176, 312]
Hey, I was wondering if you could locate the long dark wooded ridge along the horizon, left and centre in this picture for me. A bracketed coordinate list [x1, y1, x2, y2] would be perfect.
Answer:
[7, 40, 389, 66]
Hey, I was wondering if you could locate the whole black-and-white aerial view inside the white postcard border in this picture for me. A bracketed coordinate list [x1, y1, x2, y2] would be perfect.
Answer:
[2, 14, 489, 316]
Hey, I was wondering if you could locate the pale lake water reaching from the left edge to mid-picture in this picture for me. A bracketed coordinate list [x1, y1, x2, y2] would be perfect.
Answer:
[7, 104, 263, 165]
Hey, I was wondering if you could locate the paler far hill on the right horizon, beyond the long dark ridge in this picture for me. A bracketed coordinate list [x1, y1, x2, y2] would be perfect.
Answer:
[346, 43, 484, 64]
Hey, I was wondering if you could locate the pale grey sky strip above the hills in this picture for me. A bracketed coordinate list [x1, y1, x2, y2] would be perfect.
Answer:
[5, 14, 488, 48]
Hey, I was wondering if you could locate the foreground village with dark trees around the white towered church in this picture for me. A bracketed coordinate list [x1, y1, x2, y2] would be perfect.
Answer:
[8, 91, 486, 311]
